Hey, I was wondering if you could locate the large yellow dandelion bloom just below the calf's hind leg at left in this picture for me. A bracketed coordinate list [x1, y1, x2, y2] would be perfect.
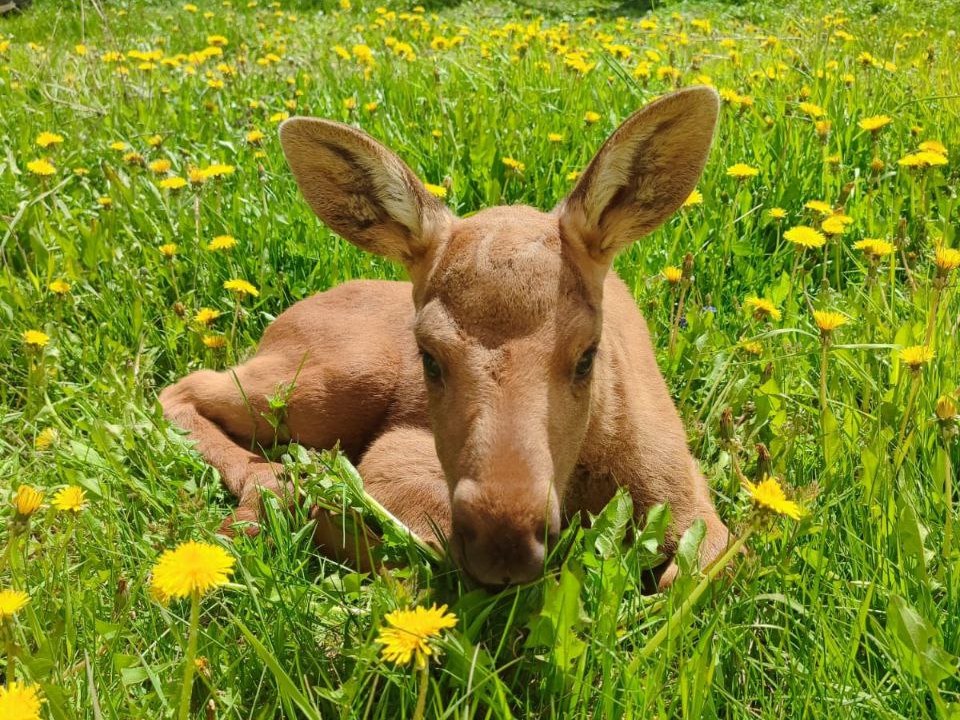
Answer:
[150, 540, 235, 598]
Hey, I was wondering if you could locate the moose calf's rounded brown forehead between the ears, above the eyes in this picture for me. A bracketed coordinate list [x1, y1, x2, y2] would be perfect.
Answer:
[425, 207, 592, 346]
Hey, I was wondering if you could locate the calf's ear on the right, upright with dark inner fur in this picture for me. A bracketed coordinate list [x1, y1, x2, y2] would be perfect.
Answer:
[557, 87, 720, 264]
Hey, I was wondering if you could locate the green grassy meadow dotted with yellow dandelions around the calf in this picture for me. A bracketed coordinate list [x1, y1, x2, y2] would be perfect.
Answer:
[0, 0, 960, 720]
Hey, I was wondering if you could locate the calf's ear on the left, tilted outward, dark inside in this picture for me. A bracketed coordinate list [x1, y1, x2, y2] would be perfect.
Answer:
[280, 117, 453, 265]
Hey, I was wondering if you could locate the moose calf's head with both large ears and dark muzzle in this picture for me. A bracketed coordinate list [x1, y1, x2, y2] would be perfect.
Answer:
[280, 88, 718, 585]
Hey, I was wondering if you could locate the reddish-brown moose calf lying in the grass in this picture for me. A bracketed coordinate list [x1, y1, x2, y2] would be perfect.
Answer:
[160, 88, 727, 586]
